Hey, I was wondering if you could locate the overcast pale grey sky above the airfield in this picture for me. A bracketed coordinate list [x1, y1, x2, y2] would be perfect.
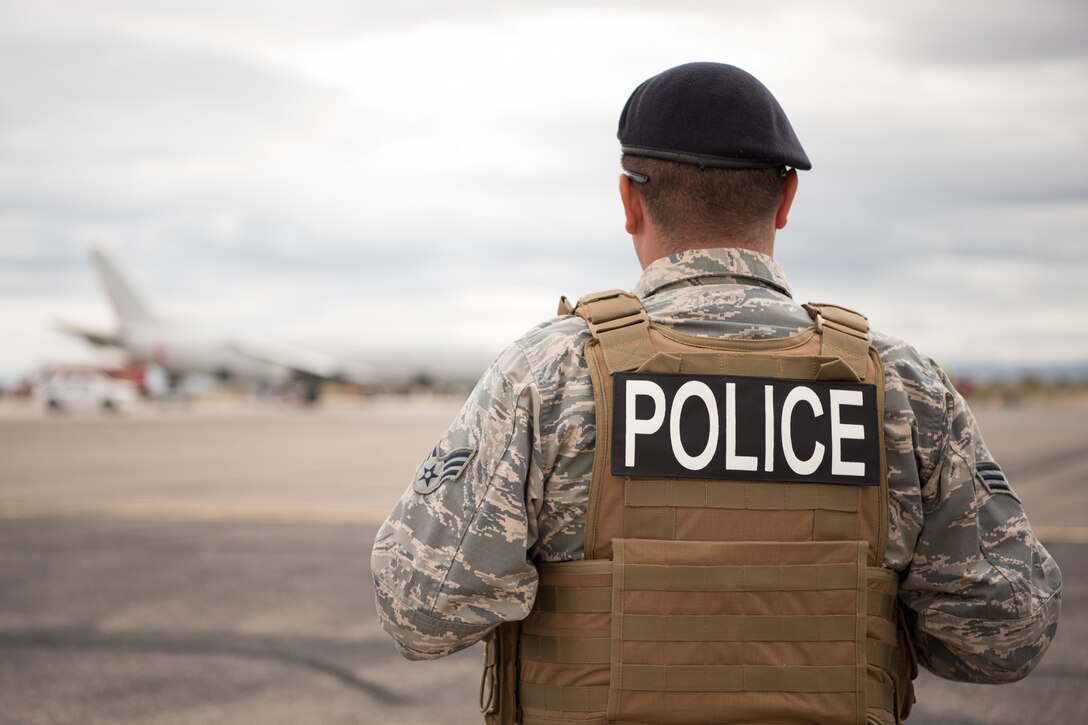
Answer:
[0, 0, 1088, 378]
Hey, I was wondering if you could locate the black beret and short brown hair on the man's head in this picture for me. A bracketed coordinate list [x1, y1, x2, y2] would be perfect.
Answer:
[617, 63, 812, 248]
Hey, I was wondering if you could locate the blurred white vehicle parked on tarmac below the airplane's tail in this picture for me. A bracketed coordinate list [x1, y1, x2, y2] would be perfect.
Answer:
[34, 365, 138, 413]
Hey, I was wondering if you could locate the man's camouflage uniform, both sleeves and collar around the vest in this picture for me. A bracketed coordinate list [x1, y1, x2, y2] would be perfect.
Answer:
[372, 248, 1061, 683]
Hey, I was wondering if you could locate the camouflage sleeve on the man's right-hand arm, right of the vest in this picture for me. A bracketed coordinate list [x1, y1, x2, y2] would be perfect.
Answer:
[901, 364, 1062, 684]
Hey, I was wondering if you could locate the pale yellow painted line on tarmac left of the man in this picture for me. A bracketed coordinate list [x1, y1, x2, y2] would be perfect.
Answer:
[0, 501, 392, 526]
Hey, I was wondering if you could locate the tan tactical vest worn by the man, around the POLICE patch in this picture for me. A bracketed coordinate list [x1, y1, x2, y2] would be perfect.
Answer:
[481, 291, 916, 725]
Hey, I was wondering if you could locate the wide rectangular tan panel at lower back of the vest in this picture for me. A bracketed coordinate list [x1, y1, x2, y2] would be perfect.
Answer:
[607, 539, 868, 725]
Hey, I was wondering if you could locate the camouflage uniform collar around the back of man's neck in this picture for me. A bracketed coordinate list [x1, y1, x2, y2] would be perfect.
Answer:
[634, 247, 793, 297]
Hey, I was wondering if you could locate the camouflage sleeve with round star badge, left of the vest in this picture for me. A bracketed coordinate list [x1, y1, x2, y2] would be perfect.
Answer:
[371, 345, 540, 660]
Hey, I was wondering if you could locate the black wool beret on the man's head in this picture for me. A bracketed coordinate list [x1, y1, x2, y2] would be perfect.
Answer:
[617, 63, 812, 169]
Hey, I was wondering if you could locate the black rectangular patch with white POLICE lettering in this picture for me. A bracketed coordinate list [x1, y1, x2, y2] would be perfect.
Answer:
[611, 372, 881, 486]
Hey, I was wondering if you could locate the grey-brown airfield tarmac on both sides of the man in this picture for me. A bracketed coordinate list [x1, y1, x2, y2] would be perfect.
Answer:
[0, 398, 1088, 725]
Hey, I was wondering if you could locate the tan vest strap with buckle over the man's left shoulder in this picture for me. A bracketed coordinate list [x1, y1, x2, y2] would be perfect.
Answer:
[574, 290, 654, 372]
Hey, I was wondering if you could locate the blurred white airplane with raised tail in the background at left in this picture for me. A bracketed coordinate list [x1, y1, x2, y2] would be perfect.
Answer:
[54, 249, 485, 402]
